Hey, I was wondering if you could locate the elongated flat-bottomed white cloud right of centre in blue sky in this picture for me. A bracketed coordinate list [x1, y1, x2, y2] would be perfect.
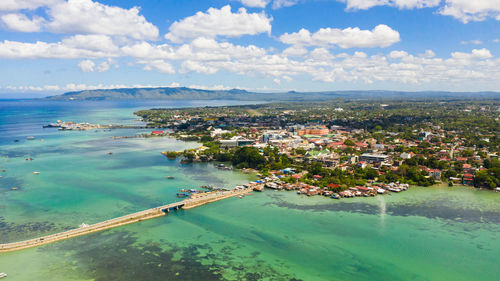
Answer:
[280, 24, 400, 49]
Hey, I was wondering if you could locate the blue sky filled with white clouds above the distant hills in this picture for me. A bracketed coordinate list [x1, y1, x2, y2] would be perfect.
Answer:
[0, 0, 500, 98]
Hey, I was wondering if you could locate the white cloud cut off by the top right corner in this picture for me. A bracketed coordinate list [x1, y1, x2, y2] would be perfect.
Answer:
[440, 0, 500, 23]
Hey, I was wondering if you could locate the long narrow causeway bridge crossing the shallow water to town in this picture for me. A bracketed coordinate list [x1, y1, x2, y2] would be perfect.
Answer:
[0, 188, 252, 253]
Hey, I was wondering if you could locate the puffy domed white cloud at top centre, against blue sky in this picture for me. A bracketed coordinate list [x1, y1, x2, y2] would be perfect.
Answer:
[165, 5, 272, 43]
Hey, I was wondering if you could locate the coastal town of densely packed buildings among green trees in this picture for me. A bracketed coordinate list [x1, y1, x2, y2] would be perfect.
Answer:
[136, 99, 500, 199]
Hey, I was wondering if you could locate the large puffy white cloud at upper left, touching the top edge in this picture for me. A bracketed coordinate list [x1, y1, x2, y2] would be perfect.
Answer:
[46, 0, 158, 39]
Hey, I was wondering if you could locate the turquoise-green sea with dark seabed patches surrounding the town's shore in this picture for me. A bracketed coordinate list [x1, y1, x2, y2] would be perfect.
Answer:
[0, 101, 500, 280]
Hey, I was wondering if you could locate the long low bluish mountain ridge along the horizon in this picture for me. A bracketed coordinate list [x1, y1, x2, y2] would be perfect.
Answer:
[45, 87, 500, 101]
